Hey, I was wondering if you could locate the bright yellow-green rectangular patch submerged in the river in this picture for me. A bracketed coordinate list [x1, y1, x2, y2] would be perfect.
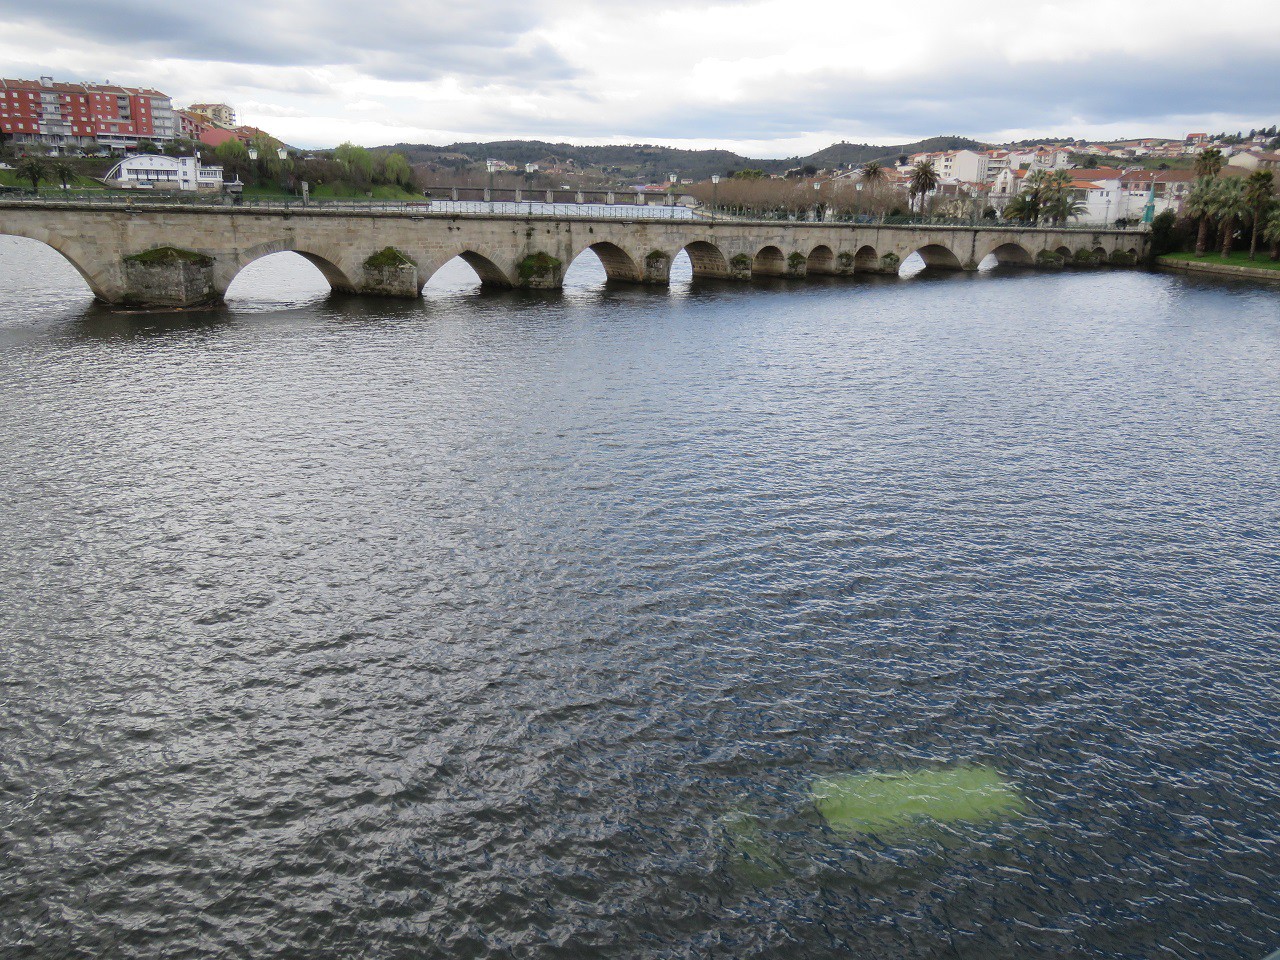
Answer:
[810, 765, 1027, 833]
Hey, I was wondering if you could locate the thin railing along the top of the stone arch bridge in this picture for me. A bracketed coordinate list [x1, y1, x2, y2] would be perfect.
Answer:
[0, 191, 1148, 233]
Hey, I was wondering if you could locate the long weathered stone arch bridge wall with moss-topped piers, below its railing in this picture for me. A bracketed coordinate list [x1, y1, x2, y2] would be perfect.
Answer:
[0, 200, 1148, 308]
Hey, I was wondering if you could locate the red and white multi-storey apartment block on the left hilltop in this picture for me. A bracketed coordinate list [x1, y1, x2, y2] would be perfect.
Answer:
[0, 77, 178, 148]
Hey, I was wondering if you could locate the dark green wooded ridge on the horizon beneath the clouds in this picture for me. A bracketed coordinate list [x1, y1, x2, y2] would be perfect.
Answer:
[378, 137, 983, 182]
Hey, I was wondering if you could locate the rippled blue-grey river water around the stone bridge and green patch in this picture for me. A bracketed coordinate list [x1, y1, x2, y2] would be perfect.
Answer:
[0, 238, 1280, 960]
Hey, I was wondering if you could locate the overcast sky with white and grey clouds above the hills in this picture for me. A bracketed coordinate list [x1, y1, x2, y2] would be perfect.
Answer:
[0, 0, 1280, 156]
